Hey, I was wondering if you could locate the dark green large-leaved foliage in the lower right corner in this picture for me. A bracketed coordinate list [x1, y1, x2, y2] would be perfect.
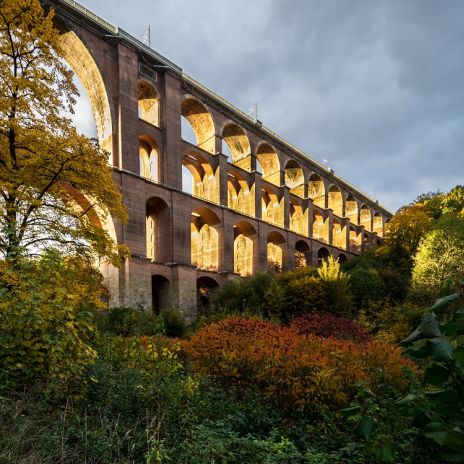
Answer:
[401, 294, 464, 462]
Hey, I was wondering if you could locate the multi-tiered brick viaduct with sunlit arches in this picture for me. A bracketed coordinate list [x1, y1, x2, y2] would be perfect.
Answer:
[44, 0, 391, 318]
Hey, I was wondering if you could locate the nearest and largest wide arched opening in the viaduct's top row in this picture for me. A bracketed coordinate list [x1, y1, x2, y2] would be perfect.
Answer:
[181, 97, 216, 155]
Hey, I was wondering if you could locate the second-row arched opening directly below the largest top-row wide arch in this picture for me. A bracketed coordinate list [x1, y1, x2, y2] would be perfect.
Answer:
[182, 152, 219, 204]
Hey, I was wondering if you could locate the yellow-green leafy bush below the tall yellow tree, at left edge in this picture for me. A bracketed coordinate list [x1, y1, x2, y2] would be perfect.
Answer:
[0, 253, 102, 395]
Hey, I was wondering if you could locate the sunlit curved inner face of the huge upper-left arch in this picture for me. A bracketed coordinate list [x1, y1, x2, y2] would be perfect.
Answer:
[60, 31, 115, 158]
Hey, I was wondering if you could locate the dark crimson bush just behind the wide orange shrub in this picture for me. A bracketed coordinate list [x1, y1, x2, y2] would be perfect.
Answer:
[290, 313, 372, 343]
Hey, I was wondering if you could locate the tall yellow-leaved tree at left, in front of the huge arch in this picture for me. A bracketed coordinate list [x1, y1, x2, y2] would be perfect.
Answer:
[0, 0, 126, 263]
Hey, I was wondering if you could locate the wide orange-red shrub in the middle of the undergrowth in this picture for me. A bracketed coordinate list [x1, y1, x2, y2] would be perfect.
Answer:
[183, 317, 414, 412]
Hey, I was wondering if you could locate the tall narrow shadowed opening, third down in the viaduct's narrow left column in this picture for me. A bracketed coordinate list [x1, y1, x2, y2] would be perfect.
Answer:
[146, 197, 171, 263]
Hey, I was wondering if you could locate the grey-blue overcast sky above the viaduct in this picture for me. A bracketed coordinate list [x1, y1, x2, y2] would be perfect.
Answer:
[70, 0, 464, 211]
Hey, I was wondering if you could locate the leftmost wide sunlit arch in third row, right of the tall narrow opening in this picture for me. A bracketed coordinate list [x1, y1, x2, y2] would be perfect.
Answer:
[190, 208, 221, 271]
